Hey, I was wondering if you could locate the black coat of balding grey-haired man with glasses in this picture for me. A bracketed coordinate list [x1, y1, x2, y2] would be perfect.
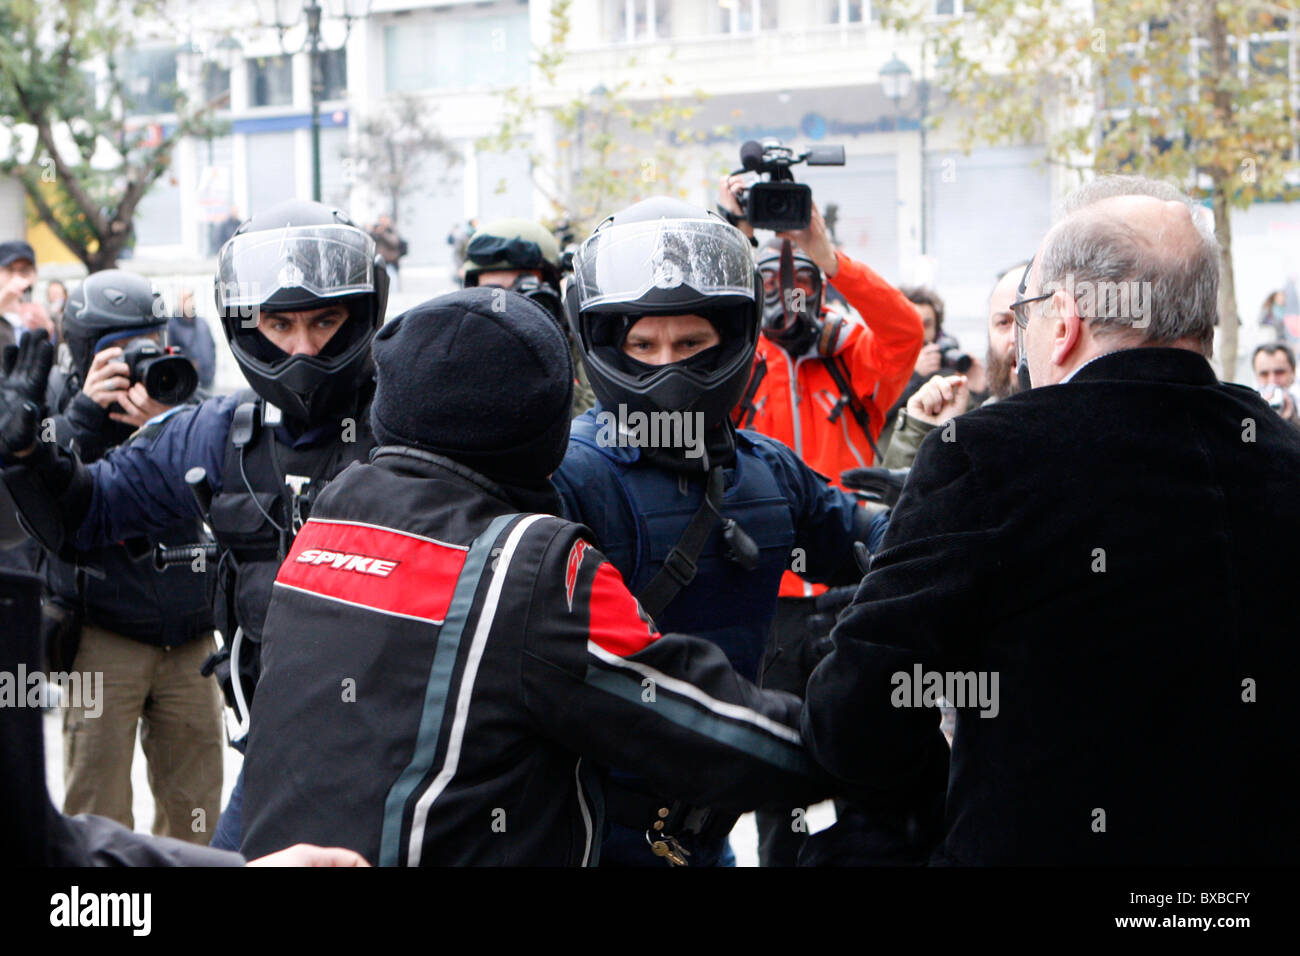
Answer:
[803, 349, 1300, 864]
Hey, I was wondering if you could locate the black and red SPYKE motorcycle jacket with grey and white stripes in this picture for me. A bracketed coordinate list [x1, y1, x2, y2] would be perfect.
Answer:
[242, 447, 822, 865]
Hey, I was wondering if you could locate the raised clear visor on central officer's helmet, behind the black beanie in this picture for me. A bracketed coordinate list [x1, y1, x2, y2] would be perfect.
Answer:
[573, 219, 754, 310]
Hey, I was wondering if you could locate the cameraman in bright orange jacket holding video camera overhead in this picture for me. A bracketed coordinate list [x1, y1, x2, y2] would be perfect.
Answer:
[719, 176, 922, 865]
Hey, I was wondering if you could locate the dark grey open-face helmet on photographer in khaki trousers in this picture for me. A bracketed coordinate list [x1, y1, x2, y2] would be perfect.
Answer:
[62, 269, 168, 382]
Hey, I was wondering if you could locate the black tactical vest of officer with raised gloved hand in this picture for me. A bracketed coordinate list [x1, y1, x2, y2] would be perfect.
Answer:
[209, 392, 374, 644]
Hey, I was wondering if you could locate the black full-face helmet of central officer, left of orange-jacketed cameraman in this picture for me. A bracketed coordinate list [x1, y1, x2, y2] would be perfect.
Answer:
[564, 196, 762, 429]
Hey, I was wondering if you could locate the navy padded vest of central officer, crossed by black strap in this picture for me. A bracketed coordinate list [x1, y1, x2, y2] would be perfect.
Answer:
[562, 416, 794, 682]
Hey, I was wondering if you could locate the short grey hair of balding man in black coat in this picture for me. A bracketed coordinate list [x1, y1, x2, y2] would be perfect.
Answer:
[1040, 176, 1219, 356]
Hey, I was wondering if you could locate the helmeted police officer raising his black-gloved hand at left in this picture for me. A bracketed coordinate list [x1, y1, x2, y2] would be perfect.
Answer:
[0, 200, 389, 847]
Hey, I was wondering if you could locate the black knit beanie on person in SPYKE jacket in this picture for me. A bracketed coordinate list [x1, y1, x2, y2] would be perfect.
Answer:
[371, 286, 573, 486]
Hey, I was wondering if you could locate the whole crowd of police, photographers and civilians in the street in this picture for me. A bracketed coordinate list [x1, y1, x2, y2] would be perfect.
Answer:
[0, 176, 1300, 866]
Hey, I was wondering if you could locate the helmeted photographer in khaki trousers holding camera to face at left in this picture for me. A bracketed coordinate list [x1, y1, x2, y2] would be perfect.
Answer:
[46, 269, 222, 844]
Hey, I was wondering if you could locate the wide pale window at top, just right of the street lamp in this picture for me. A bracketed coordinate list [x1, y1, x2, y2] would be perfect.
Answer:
[384, 8, 532, 92]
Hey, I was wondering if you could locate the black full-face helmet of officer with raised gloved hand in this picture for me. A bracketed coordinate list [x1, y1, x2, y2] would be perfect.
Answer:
[215, 199, 389, 424]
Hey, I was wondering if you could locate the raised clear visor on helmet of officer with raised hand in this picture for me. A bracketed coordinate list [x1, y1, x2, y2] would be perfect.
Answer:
[217, 225, 374, 308]
